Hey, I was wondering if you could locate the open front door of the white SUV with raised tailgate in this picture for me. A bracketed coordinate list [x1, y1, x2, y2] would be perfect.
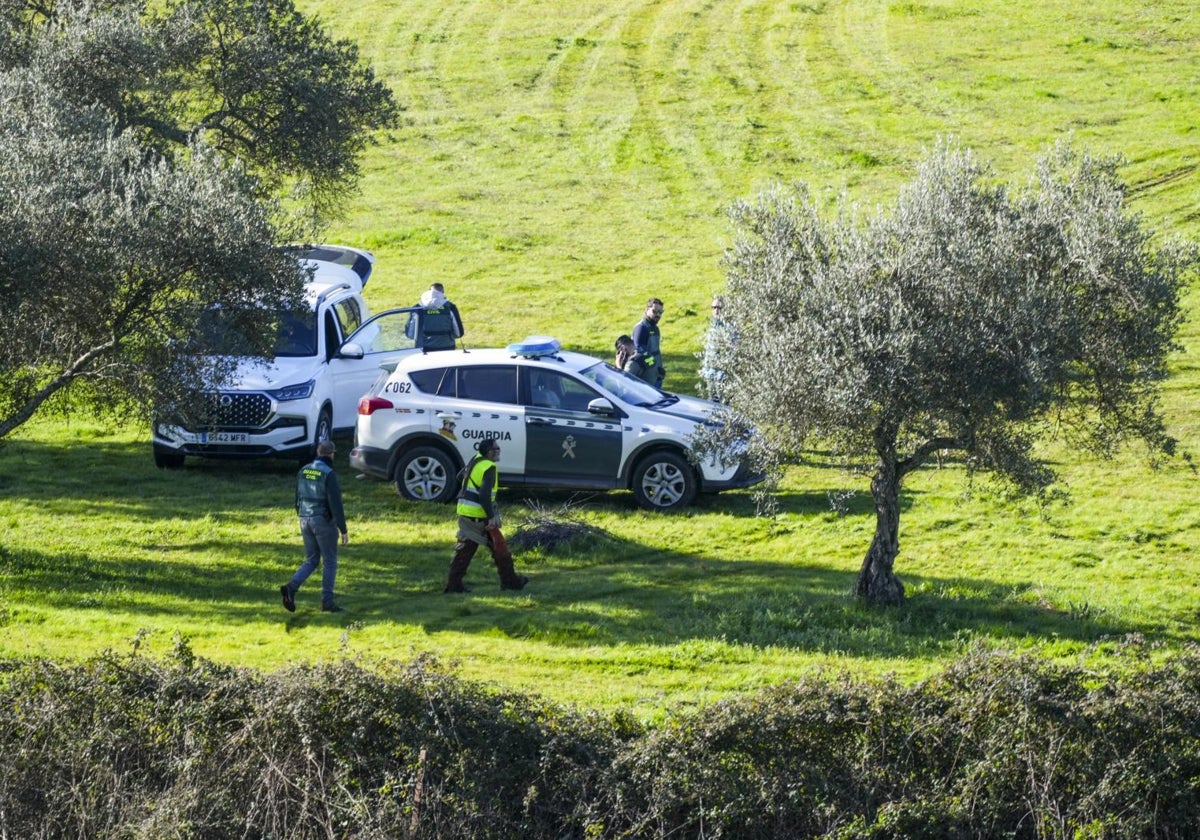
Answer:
[329, 307, 415, 428]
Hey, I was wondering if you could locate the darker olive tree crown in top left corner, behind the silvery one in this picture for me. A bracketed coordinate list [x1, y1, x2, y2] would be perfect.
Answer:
[0, 0, 397, 218]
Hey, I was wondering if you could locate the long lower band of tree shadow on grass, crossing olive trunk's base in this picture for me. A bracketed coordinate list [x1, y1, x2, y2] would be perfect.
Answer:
[0, 532, 1146, 658]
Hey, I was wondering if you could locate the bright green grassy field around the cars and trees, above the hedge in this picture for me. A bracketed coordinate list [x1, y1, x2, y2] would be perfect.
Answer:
[0, 0, 1200, 718]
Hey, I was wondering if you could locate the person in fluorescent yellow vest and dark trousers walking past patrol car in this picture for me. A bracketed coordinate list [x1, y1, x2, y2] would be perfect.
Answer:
[443, 438, 529, 593]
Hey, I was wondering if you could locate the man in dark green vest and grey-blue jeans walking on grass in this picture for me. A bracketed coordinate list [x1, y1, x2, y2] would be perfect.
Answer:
[280, 438, 350, 612]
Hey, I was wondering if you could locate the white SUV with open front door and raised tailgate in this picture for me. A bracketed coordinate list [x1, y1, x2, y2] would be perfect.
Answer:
[152, 245, 421, 468]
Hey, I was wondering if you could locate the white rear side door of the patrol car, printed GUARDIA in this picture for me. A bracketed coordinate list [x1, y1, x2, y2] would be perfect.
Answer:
[438, 362, 526, 472]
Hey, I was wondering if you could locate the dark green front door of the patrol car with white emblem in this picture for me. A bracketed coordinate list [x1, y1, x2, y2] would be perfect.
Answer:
[521, 367, 622, 487]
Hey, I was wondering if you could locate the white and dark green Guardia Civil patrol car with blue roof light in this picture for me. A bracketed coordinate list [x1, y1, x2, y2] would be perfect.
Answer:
[350, 336, 761, 510]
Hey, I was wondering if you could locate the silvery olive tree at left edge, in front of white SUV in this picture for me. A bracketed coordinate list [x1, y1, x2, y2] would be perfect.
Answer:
[0, 73, 304, 438]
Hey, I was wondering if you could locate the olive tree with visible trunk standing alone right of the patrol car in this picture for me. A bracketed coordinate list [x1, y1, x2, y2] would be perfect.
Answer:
[710, 143, 1196, 605]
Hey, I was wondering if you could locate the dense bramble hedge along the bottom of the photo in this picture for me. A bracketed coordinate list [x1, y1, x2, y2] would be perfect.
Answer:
[0, 644, 1200, 840]
